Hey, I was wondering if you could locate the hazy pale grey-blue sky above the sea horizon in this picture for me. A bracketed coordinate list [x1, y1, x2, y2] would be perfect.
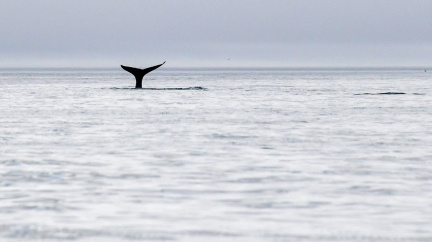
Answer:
[0, 0, 432, 68]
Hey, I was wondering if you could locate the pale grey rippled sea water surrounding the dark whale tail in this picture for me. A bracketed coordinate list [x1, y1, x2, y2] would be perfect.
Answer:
[0, 69, 432, 241]
